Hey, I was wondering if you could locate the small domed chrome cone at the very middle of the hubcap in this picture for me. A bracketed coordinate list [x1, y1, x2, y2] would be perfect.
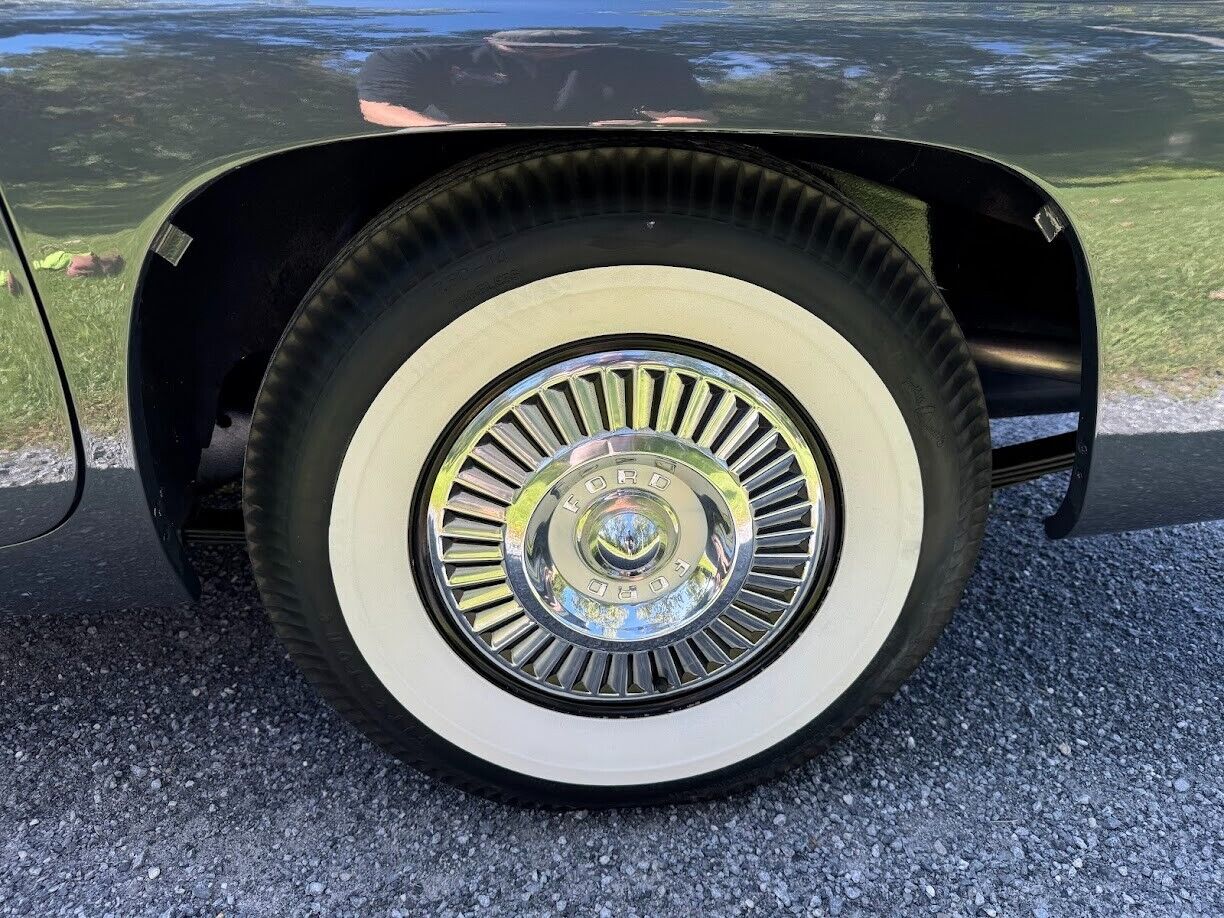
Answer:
[578, 490, 679, 579]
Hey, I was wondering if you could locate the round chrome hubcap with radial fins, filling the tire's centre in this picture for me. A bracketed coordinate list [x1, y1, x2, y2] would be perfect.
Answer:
[422, 350, 830, 705]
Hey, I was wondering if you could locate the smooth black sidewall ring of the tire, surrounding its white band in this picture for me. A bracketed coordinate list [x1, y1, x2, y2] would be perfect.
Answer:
[258, 214, 965, 805]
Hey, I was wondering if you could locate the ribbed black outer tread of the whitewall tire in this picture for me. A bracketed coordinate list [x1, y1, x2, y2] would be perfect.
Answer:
[242, 140, 990, 807]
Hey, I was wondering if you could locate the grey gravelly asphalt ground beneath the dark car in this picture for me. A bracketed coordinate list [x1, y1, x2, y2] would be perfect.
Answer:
[0, 443, 1224, 917]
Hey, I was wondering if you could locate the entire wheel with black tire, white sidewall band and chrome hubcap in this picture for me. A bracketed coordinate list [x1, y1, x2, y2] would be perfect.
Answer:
[245, 144, 989, 805]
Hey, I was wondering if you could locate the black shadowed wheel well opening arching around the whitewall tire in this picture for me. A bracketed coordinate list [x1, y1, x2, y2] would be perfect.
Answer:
[130, 131, 1091, 545]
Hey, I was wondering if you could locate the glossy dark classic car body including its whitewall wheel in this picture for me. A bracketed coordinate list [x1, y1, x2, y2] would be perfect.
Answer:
[0, 0, 1224, 805]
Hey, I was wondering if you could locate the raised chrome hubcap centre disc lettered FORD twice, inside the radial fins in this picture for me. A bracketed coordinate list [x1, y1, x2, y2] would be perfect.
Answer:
[503, 440, 753, 649]
